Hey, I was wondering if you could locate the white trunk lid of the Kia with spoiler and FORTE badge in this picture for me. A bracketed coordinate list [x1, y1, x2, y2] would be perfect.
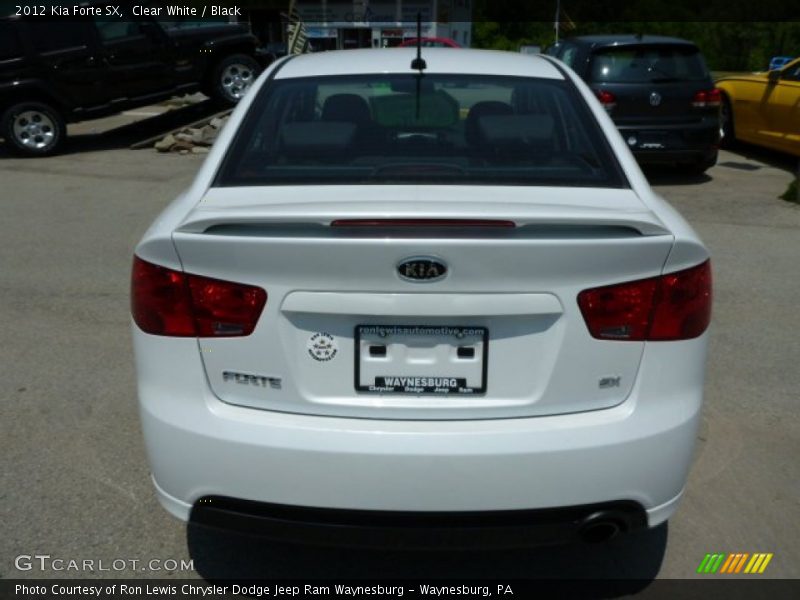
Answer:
[174, 186, 673, 419]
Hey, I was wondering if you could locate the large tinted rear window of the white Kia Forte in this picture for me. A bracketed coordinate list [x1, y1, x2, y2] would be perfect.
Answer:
[216, 74, 623, 187]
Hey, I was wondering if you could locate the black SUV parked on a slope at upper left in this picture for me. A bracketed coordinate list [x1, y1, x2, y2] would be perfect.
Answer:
[0, 5, 263, 156]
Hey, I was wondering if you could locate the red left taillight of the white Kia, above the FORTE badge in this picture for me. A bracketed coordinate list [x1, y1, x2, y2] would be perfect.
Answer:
[131, 256, 267, 337]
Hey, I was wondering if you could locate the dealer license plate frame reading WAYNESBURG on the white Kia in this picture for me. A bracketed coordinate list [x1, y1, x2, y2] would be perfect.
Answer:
[353, 324, 489, 396]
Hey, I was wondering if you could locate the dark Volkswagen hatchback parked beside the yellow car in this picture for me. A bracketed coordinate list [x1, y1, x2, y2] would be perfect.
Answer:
[547, 35, 721, 174]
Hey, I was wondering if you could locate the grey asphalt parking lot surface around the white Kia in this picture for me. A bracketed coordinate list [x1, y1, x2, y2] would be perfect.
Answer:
[0, 127, 800, 580]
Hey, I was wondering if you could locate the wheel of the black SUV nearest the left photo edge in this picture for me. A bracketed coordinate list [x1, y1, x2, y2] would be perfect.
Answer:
[0, 102, 67, 156]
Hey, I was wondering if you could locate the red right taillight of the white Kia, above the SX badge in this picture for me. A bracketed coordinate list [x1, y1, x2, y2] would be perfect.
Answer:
[578, 261, 711, 341]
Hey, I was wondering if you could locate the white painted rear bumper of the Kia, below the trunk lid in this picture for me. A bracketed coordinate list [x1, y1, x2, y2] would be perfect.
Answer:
[134, 331, 707, 537]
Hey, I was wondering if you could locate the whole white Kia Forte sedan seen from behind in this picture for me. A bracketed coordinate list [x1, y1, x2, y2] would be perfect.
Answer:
[132, 48, 711, 546]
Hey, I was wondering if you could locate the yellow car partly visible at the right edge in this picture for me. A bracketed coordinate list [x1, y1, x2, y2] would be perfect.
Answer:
[717, 58, 800, 156]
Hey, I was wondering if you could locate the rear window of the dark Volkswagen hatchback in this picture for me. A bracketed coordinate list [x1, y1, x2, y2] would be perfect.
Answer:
[591, 45, 709, 83]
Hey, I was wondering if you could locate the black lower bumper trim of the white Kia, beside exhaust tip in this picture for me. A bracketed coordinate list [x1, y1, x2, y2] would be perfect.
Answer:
[191, 497, 647, 549]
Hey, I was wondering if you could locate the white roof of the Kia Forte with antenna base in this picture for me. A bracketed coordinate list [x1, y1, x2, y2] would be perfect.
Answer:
[275, 48, 564, 79]
